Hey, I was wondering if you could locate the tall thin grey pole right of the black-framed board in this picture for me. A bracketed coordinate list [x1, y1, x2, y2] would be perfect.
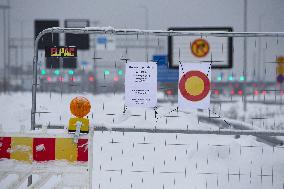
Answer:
[243, 0, 248, 111]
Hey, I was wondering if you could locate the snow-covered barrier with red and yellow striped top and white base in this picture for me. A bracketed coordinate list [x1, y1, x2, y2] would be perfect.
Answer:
[0, 133, 93, 188]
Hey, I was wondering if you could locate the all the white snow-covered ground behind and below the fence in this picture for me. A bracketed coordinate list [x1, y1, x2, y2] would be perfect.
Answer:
[0, 93, 284, 189]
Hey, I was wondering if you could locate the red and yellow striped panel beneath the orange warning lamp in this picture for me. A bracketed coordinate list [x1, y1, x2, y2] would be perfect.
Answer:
[0, 137, 88, 162]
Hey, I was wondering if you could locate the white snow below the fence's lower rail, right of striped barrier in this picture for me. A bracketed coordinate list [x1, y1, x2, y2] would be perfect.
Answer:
[93, 133, 283, 188]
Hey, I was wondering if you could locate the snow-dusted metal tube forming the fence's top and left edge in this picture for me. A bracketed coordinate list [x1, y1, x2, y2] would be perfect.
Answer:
[31, 27, 284, 130]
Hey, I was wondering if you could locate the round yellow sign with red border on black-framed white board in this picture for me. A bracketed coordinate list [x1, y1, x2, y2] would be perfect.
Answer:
[191, 38, 210, 58]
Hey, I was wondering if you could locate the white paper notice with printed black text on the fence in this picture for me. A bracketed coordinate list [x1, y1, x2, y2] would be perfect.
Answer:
[125, 62, 157, 107]
